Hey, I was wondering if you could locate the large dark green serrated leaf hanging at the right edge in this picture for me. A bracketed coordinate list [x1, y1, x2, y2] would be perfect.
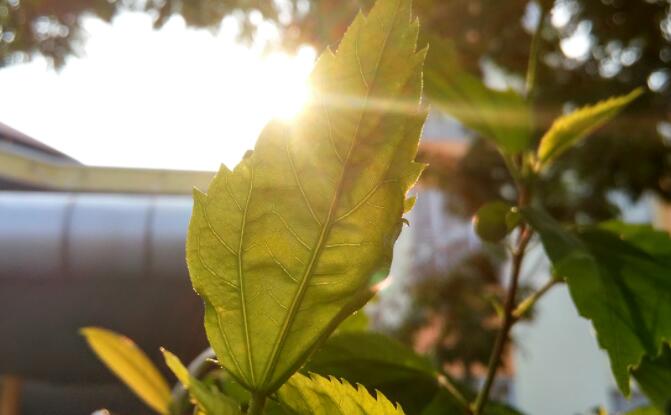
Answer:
[523, 209, 671, 394]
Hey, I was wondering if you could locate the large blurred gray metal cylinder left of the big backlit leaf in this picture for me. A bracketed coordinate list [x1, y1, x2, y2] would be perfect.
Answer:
[0, 192, 207, 399]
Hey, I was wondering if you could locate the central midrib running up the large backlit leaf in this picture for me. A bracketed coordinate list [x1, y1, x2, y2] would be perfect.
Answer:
[262, 3, 400, 388]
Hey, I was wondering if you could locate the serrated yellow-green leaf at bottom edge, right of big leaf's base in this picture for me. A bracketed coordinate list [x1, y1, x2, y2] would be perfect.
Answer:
[277, 373, 403, 415]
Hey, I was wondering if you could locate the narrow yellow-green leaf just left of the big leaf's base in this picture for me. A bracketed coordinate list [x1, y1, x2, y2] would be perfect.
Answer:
[161, 349, 240, 415]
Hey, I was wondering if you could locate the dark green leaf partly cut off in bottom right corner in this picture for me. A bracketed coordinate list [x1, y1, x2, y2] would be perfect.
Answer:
[634, 342, 671, 413]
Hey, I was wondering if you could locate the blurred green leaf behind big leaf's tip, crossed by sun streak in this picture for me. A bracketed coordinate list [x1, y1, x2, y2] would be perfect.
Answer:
[424, 38, 533, 153]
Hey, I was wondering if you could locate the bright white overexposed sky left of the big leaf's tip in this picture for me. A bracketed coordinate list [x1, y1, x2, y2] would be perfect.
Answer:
[0, 12, 315, 170]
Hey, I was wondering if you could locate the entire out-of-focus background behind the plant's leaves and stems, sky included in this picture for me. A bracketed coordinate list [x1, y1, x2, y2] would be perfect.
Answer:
[0, 0, 671, 415]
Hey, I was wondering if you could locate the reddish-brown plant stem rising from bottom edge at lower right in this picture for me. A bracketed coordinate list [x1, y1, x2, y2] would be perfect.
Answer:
[472, 225, 532, 415]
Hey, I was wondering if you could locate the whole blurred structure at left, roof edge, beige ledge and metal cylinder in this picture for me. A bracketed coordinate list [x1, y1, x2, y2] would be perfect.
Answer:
[0, 124, 212, 415]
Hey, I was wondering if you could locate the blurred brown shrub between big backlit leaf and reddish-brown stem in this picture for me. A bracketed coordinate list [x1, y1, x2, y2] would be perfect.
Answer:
[394, 249, 533, 384]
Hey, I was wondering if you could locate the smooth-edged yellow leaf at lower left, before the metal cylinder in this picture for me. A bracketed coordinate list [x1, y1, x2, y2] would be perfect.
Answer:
[80, 327, 170, 415]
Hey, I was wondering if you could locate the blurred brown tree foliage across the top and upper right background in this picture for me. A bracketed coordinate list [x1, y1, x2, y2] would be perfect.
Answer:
[0, 0, 671, 220]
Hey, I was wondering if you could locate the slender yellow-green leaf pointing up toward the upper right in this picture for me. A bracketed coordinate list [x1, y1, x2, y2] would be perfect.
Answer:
[537, 88, 643, 170]
